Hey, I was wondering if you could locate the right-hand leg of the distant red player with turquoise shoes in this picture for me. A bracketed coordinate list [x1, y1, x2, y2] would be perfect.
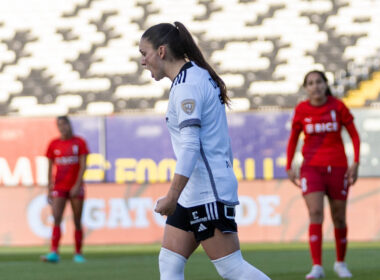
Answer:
[70, 198, 86, 263]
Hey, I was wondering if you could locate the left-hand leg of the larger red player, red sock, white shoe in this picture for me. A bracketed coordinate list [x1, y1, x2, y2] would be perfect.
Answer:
[304, 192, 325, 279]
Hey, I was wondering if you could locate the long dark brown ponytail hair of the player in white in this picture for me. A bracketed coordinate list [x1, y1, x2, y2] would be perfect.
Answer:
[142, 21, 230, 105]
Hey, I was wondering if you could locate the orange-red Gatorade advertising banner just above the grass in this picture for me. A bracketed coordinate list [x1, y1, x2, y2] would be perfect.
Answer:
[0, 179, 380, 246]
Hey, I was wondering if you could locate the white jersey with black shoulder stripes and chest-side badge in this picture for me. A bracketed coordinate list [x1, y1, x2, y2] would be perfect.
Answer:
[166, 62, 239, 207]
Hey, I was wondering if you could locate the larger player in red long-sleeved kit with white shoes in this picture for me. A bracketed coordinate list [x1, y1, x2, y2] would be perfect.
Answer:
[286, 71, 360, 279]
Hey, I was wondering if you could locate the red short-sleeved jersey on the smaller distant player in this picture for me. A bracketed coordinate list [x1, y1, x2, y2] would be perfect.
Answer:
[46, 136, 88, 191]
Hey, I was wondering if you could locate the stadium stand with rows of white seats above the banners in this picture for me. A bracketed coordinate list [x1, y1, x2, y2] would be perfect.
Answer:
[0, 0, 380, 116]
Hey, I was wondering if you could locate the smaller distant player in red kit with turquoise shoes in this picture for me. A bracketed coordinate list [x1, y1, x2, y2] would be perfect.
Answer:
[41, 116, 88, 263]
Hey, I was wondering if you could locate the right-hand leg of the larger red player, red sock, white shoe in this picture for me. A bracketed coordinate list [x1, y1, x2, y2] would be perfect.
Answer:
[329, 199, 352, 278]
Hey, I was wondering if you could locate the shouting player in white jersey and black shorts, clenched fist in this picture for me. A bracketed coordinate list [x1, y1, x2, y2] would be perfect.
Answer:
[139, 22, 269, 280]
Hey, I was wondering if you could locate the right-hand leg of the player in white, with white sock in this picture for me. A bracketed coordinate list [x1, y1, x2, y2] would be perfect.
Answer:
[201, 229, 270, 280]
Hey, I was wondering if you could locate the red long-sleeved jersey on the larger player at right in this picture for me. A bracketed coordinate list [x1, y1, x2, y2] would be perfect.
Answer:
[287, 96, 359, 169]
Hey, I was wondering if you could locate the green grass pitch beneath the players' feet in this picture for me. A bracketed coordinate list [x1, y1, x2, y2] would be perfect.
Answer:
[0, 243, 380, 280]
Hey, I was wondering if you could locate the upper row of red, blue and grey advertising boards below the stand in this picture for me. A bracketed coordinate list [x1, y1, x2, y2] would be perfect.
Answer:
[0, 109, 380, 186]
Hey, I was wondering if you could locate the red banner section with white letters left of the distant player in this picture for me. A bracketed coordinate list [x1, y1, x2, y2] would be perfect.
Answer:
[0, 118, 59, 186]
